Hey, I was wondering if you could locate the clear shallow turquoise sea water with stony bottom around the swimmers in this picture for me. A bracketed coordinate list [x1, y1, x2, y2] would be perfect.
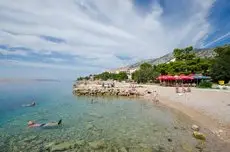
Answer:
[0, 82, 229, 152]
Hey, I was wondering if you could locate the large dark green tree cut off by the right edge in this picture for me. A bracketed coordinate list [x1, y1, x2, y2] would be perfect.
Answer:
[210, 45, 230, 83]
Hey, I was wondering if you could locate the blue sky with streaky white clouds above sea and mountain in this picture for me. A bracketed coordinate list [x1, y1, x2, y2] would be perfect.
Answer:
[0, 0, 230, 80]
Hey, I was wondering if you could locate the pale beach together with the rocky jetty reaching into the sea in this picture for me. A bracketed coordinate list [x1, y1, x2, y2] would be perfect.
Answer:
[73, 82, 230, 143]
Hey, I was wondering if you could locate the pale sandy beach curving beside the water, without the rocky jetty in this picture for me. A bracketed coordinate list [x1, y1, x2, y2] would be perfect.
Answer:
[144, 85, 230, 142]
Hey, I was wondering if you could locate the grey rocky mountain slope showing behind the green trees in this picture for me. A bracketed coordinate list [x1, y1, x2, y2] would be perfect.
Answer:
[128, 48, 215, 69]
